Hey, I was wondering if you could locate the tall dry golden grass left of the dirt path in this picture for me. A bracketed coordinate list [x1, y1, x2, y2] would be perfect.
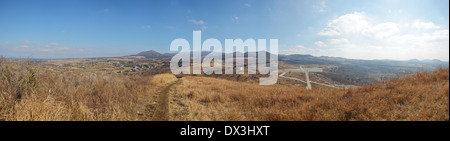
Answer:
[0, 58, 176, 121]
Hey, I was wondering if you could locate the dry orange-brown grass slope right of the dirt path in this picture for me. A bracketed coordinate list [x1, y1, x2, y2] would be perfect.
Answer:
[175, 68, 449, 121]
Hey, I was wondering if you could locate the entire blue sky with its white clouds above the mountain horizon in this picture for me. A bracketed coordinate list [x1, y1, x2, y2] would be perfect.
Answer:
[0, 0, 449, 61]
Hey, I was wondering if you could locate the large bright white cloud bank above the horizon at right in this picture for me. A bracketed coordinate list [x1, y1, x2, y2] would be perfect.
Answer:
[314, 12, 449, 61]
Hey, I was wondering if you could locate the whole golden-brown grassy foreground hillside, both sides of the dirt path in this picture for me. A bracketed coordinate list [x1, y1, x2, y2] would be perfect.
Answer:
[0, 58, 449, 121]
